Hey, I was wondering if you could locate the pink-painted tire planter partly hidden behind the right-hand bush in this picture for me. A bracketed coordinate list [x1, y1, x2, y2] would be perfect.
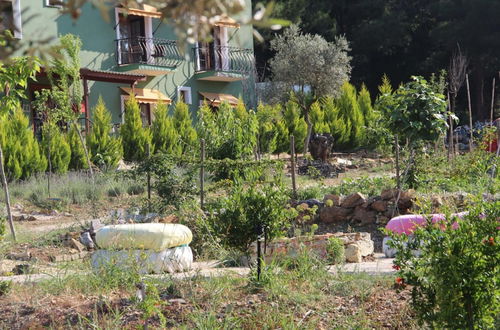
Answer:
[382, 212, 468, 258]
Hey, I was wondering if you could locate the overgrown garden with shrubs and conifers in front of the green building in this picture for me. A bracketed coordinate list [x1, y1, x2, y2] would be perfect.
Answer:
[0, 27, 500, 329]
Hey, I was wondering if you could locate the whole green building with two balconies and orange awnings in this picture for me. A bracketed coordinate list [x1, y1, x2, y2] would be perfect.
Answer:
[0, 0, 255, 132]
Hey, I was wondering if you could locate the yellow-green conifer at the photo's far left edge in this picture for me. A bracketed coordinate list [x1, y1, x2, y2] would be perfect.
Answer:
[0, 108, 47, 180]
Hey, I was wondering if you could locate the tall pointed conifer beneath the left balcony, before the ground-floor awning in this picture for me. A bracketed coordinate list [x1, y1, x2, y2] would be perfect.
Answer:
[120, 95, 153, 161]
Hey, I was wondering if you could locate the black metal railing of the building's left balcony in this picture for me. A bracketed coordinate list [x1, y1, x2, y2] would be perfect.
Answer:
[116, 37, 182, 67]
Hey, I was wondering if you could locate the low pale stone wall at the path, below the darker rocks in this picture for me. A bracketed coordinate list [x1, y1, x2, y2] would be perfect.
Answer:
[250, 232, 374, 262]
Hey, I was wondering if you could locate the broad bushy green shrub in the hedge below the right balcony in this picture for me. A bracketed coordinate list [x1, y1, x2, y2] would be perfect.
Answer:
[197, 102, 258, 159]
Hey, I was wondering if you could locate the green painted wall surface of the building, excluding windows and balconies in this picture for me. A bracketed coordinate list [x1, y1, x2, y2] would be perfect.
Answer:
[14, 0, 254, 123]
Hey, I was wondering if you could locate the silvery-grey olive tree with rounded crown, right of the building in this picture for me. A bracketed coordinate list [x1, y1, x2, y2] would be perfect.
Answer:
[270, 25, 351, 153]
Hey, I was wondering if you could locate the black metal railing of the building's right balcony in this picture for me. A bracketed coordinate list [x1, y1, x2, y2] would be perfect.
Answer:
[194, 44, 254, 73]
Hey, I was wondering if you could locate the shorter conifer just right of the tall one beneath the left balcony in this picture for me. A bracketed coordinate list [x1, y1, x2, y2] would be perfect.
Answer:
[151, 103, 182, 155]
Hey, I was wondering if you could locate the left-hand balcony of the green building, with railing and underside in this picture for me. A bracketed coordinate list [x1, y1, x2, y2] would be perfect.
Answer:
[116, 37, 183, 76]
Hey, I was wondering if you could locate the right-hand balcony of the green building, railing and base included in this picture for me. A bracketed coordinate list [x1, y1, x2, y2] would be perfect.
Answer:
[193, 44, 254, 82]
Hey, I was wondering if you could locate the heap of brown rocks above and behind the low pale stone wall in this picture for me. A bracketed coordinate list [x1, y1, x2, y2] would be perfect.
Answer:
[319, 189, 415, 225]
